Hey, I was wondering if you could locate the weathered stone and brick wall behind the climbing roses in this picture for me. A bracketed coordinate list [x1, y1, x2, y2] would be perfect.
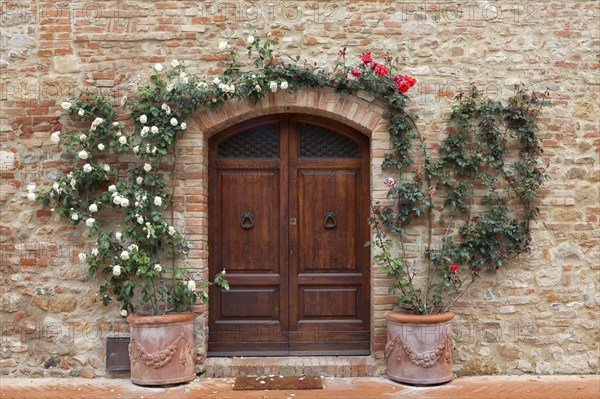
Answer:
[0, 0, 600, 376]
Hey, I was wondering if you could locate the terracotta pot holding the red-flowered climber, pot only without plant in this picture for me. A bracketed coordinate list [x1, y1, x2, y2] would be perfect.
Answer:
[385, 312, 454, 385]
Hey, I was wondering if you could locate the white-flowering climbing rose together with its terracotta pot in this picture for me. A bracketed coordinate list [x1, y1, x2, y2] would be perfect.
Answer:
[29, 88, 227, 385]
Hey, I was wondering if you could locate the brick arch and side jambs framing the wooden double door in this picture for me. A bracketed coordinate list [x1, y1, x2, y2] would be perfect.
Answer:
[175, 88, 396, 365]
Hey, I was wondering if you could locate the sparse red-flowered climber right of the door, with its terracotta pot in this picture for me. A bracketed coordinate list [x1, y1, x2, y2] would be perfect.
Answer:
[369, 86, 547, 385]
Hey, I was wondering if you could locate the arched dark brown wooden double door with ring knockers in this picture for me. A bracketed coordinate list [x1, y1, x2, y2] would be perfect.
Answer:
[208, 114, 370, 356]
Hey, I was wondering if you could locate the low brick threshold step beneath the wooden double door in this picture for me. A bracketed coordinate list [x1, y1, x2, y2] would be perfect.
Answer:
[204, 356, 384, 378]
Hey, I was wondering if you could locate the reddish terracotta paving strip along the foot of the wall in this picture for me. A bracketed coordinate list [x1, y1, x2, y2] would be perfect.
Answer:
[0, 375, 600, 399]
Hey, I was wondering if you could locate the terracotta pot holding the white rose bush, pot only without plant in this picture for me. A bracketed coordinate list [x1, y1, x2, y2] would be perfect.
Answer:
[127, 313, 196, 385]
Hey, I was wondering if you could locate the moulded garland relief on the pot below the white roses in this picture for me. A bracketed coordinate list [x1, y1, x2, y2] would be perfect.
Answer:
[129, 333, 196, 369]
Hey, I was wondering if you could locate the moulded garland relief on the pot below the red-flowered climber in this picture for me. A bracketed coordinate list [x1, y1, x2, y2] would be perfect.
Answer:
[385, 334, 453, 368]
